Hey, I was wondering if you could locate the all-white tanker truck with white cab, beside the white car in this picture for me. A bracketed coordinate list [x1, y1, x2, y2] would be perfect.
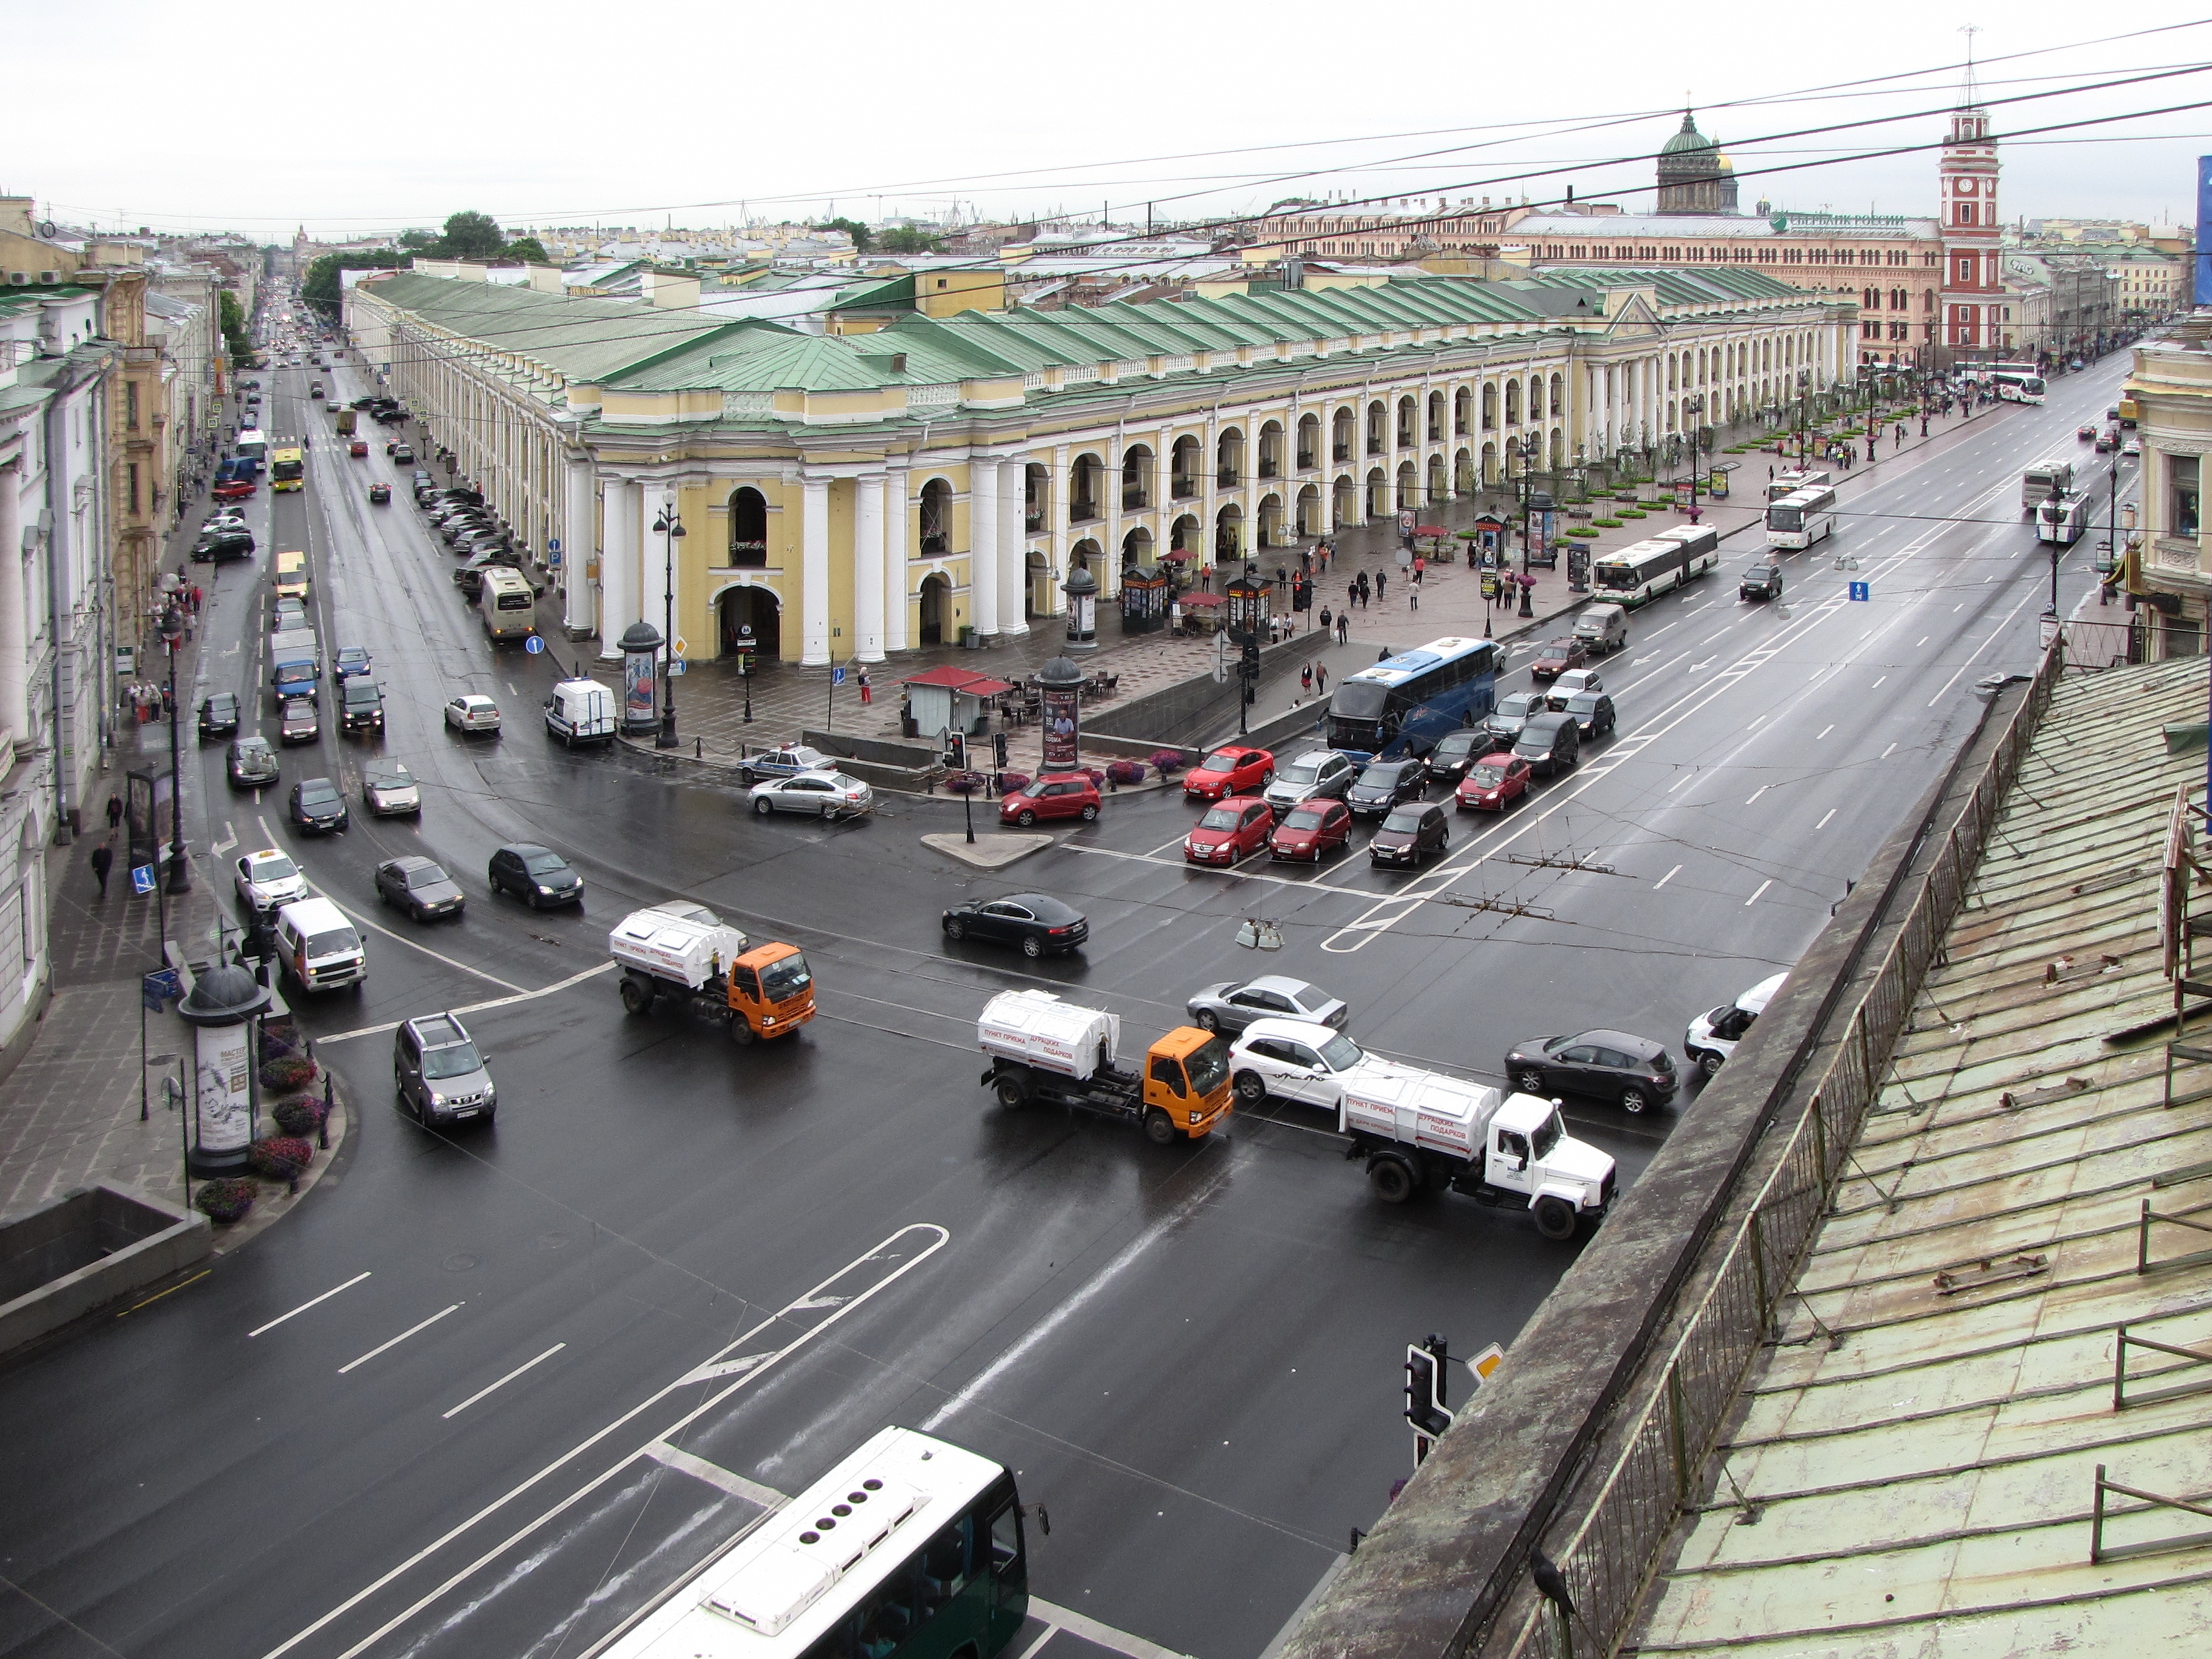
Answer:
[1336, 1068, 1617, 1239]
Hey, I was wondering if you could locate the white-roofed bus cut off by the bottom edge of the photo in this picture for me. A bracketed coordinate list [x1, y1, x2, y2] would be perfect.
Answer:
[584, 1429, 1028, 1659]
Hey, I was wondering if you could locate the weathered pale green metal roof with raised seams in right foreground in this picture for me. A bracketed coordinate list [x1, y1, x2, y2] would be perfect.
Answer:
[1624, 659, 2212, 1659]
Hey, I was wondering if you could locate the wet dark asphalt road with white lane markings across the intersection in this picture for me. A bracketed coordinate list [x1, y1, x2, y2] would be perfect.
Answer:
[0, 338, 2133, 1659]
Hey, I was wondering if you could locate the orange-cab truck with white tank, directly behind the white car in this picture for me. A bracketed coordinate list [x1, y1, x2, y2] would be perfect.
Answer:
[976, 991, 1235, 1146]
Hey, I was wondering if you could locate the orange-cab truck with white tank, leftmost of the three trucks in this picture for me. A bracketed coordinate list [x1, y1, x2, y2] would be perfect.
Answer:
[606, 900, 814, 1042]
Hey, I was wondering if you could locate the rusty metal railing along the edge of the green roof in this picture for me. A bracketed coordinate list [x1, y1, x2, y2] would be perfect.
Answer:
[1495, 644, 2064, 1659]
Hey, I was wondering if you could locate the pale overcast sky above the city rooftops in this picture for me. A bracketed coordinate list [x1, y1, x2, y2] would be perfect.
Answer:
[13, 0, 2212, 241]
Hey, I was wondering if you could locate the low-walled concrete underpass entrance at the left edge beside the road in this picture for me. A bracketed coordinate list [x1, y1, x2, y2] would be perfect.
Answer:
[0, 1181, 215, 1354]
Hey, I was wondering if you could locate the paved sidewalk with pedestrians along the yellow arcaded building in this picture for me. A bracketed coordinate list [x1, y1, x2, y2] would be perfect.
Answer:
[628, 409, 1989, 770]
